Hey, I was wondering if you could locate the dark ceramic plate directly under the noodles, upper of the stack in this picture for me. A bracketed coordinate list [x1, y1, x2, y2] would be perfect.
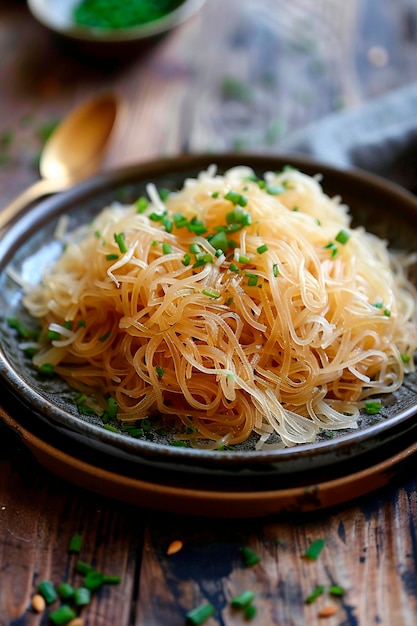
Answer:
[0, 155, 417, 488]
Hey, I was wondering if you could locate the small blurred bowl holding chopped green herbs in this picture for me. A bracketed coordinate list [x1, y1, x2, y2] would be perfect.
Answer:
[27, 0, 205, 56]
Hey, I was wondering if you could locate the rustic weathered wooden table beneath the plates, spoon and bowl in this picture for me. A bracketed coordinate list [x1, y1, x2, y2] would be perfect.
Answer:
[0, 0, 417, 626]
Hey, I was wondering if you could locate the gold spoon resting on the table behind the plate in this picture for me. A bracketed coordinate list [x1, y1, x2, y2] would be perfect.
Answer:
[0, 93, 117, 229]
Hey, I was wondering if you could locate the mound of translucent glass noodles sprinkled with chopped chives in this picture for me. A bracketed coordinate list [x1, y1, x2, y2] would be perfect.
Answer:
[24, 167, 417, 448]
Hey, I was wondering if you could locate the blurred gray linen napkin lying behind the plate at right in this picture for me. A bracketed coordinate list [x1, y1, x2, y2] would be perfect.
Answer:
[278, 84, 417, 192]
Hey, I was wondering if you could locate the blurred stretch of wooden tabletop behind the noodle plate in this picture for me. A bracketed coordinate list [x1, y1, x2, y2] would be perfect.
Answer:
[0, 0, 417, 204]
